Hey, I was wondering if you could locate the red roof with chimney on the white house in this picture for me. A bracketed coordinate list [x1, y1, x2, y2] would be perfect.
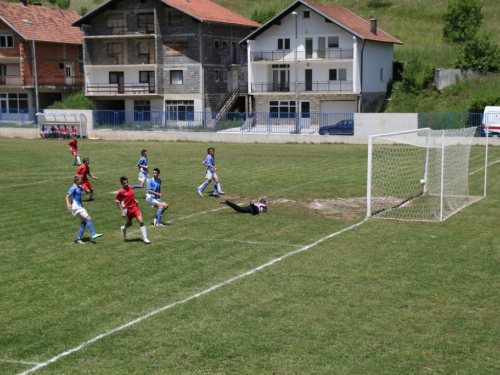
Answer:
[302, 0, 403, 44]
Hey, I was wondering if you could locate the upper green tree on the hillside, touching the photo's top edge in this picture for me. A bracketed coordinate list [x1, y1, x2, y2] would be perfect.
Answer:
[443, 0, 483, 43]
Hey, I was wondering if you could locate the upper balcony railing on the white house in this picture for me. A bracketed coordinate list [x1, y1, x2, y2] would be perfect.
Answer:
[252, 48, 353, 61]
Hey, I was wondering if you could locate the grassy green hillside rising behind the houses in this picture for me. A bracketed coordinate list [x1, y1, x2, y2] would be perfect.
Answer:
[45, 0, 500, 112]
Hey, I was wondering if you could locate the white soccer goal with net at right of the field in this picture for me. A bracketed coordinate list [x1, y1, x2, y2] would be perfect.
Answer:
[367, 127, 486, 222]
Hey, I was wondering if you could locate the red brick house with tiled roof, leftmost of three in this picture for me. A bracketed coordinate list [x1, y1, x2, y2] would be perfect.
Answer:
[0, 0, 83, 116]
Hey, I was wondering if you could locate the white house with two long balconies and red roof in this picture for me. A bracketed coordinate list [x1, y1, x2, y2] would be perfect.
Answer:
[240, 0, 402, 120]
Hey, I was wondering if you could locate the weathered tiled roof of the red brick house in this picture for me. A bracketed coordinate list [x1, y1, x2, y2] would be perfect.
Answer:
[0, 2, 82, 44]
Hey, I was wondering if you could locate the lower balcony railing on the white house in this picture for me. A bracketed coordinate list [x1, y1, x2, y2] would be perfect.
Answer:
[252, 81, 353, 93]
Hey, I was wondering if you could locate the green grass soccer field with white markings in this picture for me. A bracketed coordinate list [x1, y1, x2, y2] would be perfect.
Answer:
[0, 138, 500, 375]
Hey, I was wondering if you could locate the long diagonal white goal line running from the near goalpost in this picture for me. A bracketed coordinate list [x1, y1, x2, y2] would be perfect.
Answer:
[18, 218, 368, 375]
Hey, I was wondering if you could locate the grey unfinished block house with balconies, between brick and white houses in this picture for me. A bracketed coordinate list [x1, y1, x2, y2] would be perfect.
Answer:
[73, 0, 260, 128]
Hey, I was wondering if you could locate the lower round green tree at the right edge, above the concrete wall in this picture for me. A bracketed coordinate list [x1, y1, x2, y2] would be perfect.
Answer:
[455, 33, 500, 73]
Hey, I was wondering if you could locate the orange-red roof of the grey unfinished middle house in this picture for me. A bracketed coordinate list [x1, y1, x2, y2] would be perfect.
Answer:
[161, 0, 260, 27]
